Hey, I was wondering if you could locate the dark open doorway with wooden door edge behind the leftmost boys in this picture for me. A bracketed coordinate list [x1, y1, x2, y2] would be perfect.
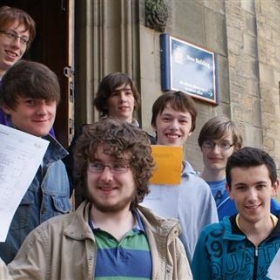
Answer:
[0, 0, 75, 148]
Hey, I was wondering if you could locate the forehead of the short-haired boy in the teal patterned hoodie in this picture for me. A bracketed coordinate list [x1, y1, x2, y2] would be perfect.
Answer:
[230, 164, 270, 185]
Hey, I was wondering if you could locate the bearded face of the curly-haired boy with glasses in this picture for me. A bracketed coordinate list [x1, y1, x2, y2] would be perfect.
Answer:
[87, 145, 136, 213]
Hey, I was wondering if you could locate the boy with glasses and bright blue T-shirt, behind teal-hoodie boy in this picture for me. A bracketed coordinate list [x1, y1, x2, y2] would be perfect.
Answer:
[198, 116, 280, 220]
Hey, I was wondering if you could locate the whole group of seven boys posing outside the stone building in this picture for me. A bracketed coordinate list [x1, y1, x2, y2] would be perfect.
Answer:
[0, 3, 280, 279]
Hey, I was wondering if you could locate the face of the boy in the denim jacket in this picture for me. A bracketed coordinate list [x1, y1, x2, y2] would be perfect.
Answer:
[4, 97, 57, 137]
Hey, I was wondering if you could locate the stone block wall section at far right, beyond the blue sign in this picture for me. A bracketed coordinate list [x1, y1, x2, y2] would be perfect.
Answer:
[225, 0, 280, 173]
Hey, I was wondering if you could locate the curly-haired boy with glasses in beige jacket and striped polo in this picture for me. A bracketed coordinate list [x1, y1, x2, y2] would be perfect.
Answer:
[0, 118, 192, 280]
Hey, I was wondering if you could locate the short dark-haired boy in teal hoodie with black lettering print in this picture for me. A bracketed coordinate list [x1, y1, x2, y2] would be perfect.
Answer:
[192, 147, 280, 280]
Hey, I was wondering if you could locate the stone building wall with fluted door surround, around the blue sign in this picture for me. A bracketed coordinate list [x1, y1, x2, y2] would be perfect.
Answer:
[75, 0, 280, 180]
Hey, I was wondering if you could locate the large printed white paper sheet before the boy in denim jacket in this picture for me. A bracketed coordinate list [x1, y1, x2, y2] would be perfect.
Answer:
[0, 125, 49, 242]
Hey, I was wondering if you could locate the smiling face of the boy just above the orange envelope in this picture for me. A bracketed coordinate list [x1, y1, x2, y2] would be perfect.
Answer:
[154, 104, 192, 146]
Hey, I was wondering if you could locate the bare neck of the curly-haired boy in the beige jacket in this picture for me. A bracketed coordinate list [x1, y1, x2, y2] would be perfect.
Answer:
[90, 205, 135, 240]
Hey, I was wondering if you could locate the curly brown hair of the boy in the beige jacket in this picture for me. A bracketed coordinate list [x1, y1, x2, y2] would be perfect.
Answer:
[74, 118, 155, 209]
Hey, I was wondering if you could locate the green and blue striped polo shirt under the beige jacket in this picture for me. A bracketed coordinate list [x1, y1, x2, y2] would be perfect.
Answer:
[89, 210, 152, 280]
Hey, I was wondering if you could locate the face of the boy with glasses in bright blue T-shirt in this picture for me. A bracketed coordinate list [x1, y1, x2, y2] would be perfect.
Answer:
[201, 132, 235, 172]
